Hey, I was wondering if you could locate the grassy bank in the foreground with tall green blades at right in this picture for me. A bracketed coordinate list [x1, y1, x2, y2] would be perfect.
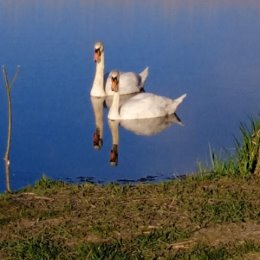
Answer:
[0, 118, 260, 260]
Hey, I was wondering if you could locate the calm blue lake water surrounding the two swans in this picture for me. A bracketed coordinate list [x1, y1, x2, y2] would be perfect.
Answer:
[0, 0, 260, 191]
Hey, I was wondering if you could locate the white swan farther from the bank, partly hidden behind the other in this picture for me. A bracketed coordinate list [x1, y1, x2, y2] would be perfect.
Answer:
[90, 42, 149, 97]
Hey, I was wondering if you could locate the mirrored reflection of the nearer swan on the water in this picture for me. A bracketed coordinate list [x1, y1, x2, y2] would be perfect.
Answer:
[108, 113, 183, 166]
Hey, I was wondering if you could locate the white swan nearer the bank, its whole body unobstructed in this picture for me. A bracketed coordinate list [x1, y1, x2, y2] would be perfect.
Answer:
[108, 71, 186, 120]
